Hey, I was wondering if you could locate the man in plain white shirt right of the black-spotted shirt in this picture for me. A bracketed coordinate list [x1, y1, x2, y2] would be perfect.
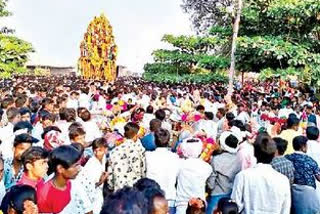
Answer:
[146, 129, 181, 213]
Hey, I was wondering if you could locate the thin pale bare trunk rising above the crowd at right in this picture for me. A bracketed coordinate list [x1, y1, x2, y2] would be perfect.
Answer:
[228, 0, 243, 96]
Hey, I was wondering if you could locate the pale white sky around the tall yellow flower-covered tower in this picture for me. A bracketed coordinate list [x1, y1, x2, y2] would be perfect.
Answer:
[3, 0, 192, 73]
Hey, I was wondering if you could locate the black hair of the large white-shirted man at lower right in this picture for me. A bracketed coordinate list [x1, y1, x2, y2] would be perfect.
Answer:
[254, 133, 277, 164]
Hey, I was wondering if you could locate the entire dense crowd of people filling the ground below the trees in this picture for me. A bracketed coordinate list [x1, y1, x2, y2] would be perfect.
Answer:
[0, 76, 320, 214]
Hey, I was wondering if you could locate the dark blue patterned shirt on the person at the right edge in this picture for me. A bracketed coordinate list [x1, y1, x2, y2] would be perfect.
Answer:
[285, 152, 320, 189]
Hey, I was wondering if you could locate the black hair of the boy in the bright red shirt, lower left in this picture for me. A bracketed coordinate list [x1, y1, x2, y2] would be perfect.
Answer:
[49, 145, 82, 172]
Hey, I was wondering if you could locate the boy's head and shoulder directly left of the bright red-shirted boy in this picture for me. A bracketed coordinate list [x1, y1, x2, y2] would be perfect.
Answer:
[17, 146, 48, 188]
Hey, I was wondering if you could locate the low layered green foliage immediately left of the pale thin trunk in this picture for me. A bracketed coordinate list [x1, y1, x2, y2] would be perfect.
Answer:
[144, 35, 230, 83]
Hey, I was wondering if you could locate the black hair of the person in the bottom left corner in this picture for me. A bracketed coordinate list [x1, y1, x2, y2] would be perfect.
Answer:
[1, 185, 37, 214]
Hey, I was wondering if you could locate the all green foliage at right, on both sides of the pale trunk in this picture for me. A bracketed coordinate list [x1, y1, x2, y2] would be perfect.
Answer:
[145, 0, 320, 87]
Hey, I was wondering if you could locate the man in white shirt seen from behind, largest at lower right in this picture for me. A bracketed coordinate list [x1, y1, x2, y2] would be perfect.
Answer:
[231, 134, 291, 214]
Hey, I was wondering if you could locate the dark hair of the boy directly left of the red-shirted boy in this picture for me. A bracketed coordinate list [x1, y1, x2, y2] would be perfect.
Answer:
[21, 146, 49, 171]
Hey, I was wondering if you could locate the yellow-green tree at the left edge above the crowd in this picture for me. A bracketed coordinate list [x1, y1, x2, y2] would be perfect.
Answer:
[0, 0, 34, 78]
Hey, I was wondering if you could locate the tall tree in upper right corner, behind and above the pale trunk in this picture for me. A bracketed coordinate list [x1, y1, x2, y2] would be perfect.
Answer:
[183, 0, 320, 86]
